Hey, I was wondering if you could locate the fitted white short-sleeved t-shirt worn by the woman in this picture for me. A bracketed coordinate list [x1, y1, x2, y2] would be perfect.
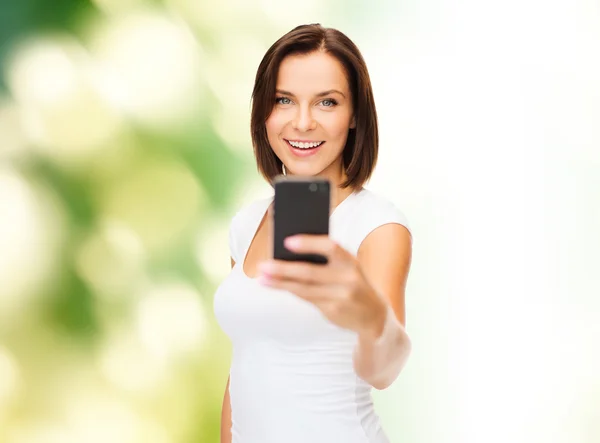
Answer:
[214, 188, 410, 443]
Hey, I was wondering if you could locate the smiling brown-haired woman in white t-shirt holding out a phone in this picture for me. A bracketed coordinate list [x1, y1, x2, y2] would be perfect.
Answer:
[214, 25, 411, 443]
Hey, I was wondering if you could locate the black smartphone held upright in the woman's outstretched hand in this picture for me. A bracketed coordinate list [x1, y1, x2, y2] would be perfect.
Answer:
[273, 176, 331, 264]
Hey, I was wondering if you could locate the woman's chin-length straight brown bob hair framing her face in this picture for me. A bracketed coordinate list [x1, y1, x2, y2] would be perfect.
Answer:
[250, 24, 379, 188]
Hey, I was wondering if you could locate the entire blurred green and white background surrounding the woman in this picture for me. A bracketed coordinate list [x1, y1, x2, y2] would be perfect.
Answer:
[0, 0, 600, 443]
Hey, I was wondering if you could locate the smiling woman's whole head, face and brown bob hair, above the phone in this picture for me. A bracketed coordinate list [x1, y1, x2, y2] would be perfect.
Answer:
[251, 25, 379, 188]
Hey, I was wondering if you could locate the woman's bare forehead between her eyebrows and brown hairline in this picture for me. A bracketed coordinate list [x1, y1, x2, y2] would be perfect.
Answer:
[277, 52, 349, 95]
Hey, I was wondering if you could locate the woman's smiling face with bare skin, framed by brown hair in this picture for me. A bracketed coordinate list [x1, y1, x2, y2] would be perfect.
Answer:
[266, 52, 354, 181]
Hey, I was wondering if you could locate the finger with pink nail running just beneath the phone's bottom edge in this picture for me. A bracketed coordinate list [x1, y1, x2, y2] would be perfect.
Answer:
[258, 260, 340, 285]
